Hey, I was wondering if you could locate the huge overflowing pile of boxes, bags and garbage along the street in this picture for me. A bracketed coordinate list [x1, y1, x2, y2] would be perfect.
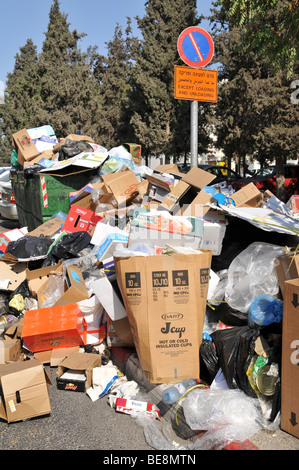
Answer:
[0, 126, 299, 449]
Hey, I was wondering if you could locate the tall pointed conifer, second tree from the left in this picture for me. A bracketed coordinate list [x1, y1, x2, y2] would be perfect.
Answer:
[36, 0, 98, 137]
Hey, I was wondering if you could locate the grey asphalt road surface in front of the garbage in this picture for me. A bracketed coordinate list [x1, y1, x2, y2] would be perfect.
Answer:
[0, 219, 299, 452]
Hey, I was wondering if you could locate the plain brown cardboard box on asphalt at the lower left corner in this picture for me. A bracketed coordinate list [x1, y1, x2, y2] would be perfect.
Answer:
[0, 359, 51, 423]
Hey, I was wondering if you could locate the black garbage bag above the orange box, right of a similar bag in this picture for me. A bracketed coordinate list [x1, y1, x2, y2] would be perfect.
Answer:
[43, 231, 91, 267]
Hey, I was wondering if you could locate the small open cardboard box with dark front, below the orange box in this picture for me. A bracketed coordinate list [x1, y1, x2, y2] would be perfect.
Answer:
[56, 352, 102, 392]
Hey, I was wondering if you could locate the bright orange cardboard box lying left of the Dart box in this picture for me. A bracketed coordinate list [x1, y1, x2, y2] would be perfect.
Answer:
[22, 304, 84, 352]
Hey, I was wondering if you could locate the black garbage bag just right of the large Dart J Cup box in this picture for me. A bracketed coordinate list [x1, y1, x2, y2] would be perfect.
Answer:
[211, 325, 260, 398]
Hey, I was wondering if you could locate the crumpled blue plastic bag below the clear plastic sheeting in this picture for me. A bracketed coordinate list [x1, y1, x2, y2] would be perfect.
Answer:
[248, 294, 283, 326]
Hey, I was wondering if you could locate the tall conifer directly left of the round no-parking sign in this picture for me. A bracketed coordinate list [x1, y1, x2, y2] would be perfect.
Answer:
[130, 0, 211, 160]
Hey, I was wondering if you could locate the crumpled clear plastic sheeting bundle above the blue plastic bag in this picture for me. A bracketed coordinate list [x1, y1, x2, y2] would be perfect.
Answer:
[225, 242, 284, 313]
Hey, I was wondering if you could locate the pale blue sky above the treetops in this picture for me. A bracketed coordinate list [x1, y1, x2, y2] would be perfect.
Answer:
[0, 0, 216, 98]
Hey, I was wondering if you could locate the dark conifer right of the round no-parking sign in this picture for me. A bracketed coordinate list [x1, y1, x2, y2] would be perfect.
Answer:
[210, 0, 299, 200]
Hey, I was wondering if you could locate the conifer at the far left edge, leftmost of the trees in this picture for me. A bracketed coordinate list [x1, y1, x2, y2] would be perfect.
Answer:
[0, 39, 38, 164]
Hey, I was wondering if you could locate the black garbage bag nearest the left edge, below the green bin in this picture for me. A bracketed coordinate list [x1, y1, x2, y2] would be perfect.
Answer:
[6, 236, 53, 259]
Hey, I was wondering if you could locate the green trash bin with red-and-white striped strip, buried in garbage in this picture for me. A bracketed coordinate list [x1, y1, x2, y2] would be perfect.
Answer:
[10, 170, 92, 232]
